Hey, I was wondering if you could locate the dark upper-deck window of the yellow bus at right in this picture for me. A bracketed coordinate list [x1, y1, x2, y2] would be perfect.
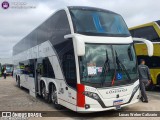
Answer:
[131, 26, 160, 42]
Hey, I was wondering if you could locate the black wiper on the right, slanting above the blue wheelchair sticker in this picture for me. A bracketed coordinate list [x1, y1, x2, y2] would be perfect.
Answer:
[115, 50, 131, 81]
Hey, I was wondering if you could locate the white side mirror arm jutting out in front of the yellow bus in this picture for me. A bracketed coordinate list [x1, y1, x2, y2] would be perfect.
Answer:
[133, 38, 153, 57]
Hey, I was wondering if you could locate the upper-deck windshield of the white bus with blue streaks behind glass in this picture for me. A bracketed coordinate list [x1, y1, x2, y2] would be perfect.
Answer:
[70, 9, 130, 37]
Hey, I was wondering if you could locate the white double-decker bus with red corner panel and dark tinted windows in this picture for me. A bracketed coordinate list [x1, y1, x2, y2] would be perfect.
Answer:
[13, 6, 153, 113]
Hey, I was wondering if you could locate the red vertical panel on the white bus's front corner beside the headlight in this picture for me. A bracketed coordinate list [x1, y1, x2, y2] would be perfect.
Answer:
[77, 84, 85, 107]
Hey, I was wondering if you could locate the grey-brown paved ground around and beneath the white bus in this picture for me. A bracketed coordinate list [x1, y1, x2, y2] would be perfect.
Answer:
[0, 77, 160, 120]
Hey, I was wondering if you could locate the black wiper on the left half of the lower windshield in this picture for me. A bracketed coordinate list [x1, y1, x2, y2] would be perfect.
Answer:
[101, 50, 110, 86]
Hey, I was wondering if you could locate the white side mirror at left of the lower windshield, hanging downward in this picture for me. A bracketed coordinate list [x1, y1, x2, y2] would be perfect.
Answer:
[64, 34, 85, 56]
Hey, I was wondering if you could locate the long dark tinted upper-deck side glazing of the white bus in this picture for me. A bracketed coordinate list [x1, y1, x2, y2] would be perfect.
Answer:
[13, 10, 70, 55]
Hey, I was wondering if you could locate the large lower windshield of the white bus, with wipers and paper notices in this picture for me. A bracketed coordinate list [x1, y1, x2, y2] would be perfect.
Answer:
[79, 44, 138, 87]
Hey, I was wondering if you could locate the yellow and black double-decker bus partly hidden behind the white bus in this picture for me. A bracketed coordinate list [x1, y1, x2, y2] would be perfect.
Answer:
[130, 20, 160, 89]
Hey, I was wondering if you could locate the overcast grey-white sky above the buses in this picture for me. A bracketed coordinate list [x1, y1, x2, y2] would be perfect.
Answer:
[0, 0, 160, 58]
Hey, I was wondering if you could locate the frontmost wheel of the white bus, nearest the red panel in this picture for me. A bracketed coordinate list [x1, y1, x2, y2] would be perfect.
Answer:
[50, 85, 62, 110]
